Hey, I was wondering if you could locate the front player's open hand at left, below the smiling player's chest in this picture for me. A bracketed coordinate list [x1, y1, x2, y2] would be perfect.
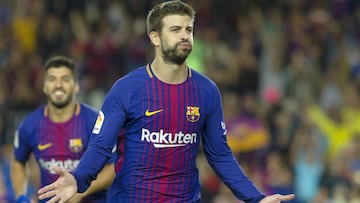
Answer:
[38, 167, 77, 203]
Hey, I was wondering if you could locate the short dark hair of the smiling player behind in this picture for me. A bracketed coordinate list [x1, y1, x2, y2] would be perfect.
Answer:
[44, 56, 78, 81]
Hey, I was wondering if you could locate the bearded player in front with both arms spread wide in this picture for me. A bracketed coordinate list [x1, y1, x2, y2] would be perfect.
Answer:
[38, 0, 294, 203]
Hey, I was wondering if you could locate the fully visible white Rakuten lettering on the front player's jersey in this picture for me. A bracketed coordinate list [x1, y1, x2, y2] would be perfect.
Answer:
[141, 128, 197, 148]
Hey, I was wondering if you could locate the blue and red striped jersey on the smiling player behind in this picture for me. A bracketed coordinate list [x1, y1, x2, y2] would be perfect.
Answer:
[14, 103, 111, 202]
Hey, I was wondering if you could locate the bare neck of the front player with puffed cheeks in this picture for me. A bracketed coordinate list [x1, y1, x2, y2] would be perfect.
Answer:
[151, 59, 188, 84]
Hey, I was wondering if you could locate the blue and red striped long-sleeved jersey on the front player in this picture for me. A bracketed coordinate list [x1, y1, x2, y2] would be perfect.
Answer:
[73, 65, 264, 202]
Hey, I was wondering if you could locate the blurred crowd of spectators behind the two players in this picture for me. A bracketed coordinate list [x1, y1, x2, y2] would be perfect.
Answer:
[0, 0, 360, 203]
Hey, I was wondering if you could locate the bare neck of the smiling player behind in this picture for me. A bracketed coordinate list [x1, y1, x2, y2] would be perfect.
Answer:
[47, 102, 76, 123]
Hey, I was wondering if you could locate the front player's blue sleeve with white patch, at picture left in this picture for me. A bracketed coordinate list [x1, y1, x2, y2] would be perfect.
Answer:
[72, 82, 129, 192]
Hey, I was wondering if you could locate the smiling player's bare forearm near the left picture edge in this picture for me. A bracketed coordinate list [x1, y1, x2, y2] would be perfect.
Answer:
[10, 160, 28, 198]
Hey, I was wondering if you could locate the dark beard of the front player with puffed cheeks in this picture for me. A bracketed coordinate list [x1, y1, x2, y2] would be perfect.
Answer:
[161, 43, 192, 65]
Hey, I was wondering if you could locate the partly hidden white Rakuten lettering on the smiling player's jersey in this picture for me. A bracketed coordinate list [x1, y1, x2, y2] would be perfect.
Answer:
[39, 159, 80, 174]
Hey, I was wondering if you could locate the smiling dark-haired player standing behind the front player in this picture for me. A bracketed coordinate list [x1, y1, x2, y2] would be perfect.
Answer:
[11, 56, 116, 203]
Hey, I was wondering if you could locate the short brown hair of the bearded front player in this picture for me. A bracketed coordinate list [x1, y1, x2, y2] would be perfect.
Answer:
[146, 0, 195, 34]
